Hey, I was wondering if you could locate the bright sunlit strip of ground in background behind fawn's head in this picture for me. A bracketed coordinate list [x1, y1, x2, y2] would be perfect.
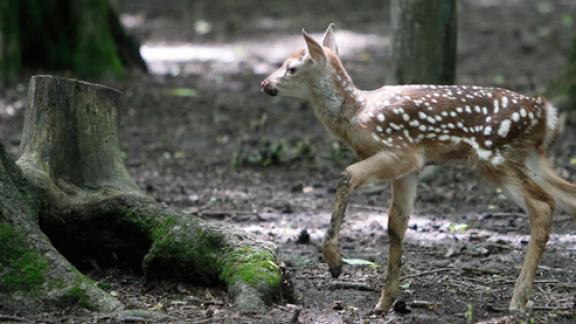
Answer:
[140, 30, 389, 75]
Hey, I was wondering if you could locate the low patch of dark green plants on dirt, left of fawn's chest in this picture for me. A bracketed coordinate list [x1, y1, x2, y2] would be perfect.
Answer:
[233, 139, 313, 167]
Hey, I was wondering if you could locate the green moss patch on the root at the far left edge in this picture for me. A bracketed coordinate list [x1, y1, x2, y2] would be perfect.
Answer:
[0, 224, 48, 292]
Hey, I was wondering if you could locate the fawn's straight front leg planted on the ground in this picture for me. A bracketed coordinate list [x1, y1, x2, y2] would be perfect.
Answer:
[374, 172, 418, 312]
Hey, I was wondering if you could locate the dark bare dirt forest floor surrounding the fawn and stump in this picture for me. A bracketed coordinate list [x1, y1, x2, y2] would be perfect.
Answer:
[0, 0, 576, 323]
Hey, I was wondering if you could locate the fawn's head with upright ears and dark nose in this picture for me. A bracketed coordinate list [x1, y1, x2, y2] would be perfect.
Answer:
[260, 24, 339, 99]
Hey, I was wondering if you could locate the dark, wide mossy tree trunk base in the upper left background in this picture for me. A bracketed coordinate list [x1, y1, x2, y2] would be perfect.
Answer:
[0, 0, 146, 79]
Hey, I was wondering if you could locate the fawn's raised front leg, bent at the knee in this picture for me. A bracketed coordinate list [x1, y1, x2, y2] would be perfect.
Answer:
[322, 152, 423, 278]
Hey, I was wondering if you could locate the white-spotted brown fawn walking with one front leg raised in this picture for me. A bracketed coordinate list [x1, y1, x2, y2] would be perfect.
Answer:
[261, 24, 576, 312]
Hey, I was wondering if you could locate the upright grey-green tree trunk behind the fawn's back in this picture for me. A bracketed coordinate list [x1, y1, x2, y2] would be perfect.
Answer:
[390, 0, 457, 84]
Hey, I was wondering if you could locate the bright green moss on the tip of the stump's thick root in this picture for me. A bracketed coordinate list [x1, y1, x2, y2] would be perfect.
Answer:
[221, 246, 282, 291]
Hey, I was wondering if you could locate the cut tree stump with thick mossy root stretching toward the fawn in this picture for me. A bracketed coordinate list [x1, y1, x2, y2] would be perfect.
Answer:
[0, 76, 282, 312]
